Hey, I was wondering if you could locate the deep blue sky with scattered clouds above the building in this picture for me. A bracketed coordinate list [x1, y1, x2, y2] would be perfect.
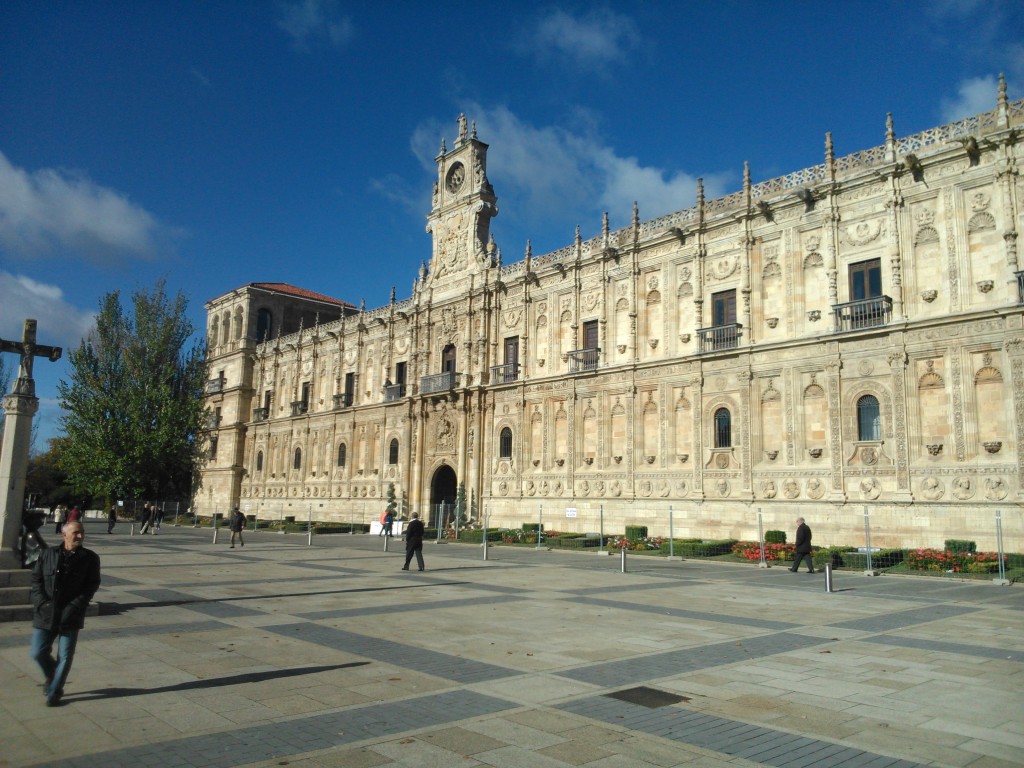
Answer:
[0, 0, 1024, 450]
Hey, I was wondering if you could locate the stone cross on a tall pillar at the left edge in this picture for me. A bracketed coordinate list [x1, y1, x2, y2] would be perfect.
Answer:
[0, 319, 61, 570]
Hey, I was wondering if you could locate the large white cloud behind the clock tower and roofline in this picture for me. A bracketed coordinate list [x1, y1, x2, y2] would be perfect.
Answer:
[413, 104, 729, 237]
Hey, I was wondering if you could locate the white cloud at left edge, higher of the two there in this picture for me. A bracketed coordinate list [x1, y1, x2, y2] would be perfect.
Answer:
[0, 153, 162, 261]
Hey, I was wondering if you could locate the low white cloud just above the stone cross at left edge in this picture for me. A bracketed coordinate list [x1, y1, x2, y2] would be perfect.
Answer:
[0, 270, 96, 354]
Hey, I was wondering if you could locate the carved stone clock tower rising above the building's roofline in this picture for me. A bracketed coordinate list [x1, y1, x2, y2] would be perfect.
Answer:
[427, 115, 498, 287]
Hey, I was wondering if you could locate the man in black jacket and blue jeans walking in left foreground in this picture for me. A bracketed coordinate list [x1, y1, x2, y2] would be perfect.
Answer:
[30, 522, 99, 707]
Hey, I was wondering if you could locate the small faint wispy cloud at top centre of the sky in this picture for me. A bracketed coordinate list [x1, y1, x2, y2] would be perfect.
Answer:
[520, 8, 640, 68]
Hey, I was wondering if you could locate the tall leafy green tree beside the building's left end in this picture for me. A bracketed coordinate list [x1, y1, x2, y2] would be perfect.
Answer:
[57, 280, 207, 502]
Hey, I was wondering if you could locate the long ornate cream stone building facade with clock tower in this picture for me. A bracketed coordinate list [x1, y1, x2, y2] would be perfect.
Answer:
[196, 80, 1024, 551]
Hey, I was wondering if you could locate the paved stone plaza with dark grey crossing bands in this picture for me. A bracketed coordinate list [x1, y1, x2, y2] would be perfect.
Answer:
[0, 522, 1024, 768]
